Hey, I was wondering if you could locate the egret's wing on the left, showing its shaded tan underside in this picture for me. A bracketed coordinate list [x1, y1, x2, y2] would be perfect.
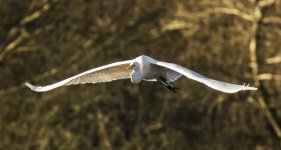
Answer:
[25, 60, 132, 92]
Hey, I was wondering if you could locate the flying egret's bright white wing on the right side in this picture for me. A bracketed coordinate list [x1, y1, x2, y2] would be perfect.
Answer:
[156, 61, 257, 93]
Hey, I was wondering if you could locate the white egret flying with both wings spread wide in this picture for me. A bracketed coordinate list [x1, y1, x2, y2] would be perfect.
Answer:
[25, 55, 257, 93]
